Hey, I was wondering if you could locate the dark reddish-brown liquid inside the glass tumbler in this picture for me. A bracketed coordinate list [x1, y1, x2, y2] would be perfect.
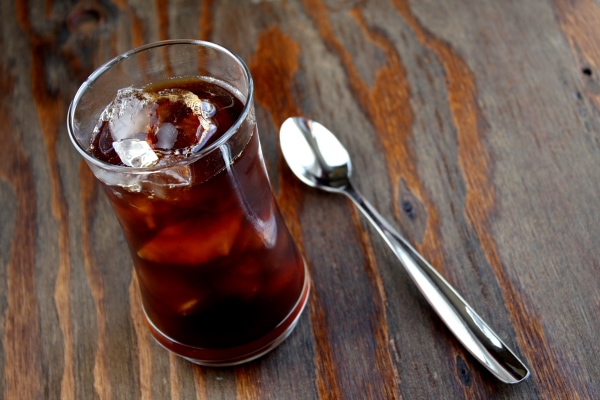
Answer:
[93, 81, 305, 359]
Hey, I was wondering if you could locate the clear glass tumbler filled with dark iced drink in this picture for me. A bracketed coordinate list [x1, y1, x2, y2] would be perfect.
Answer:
[67, 40, 310, 366]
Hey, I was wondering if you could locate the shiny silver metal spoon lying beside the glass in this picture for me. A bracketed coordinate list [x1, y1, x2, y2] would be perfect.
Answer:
[279, 117, 529, 384]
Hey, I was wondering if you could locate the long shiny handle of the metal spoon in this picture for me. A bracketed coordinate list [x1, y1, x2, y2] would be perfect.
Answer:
[344, 184, 529, 384]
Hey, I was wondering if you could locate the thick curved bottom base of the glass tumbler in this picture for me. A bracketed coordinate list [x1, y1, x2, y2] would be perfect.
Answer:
[144, 265, 310, 367]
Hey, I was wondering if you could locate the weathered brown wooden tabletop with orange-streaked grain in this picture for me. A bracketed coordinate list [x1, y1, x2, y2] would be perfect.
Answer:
[0, 0, 600, 399]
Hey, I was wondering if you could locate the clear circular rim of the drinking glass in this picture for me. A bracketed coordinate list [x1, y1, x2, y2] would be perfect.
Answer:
[67, 39, 254, 174]
